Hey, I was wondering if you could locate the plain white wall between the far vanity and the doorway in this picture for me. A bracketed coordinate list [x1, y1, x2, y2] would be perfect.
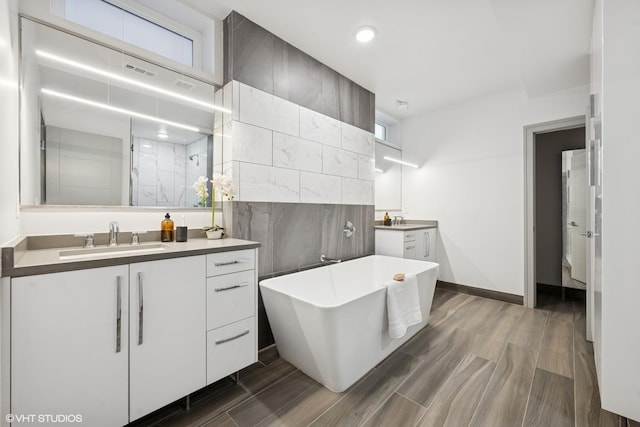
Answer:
[401, 87, 588, 295]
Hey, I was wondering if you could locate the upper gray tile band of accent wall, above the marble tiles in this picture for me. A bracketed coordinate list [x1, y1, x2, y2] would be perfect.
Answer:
[224, 11, 375, 132]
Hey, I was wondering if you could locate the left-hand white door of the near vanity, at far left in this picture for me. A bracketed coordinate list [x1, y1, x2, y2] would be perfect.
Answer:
[11, 266, 129, 427]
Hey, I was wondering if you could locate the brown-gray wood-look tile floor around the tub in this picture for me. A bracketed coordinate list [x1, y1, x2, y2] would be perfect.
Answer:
[130, 289, 622, 427]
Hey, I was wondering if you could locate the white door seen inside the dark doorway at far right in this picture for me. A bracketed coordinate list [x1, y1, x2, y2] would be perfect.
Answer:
[567, 150, 588, 283]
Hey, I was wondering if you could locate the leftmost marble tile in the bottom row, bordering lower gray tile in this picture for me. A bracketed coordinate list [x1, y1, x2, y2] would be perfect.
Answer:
[239, 162, 300, 203]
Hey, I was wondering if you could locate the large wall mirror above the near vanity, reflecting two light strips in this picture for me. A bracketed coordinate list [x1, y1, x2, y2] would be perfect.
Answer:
[20, 17, 222, 207]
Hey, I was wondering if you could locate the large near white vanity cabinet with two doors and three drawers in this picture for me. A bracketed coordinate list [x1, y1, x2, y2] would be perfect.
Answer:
[11, 249, 257, 426]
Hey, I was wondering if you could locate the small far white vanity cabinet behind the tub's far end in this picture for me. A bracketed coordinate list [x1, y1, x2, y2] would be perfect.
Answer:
[375, 227, 438, 262]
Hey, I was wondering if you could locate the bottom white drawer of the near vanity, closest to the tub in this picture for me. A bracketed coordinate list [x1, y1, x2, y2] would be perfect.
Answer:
[207, 317, 258, 385]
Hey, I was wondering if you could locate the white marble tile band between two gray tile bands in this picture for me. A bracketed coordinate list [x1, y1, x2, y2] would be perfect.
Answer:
[224, 81, 375, 205]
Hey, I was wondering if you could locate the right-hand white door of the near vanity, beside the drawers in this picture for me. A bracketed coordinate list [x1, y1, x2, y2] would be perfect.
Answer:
[130, 255, 206, 421]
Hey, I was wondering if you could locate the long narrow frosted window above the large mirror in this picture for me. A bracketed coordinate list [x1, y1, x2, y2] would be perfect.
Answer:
[65, 0, 193, 67]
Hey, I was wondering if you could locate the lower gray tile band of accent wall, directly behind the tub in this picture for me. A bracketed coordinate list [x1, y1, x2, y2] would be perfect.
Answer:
[229, 201, 375, 348]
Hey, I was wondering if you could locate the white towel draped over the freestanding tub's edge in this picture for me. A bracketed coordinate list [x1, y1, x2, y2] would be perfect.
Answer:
[387, 274, 422, 338]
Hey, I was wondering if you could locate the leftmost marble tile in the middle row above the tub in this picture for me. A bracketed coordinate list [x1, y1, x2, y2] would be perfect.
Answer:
[230, 120, 273, 166]
